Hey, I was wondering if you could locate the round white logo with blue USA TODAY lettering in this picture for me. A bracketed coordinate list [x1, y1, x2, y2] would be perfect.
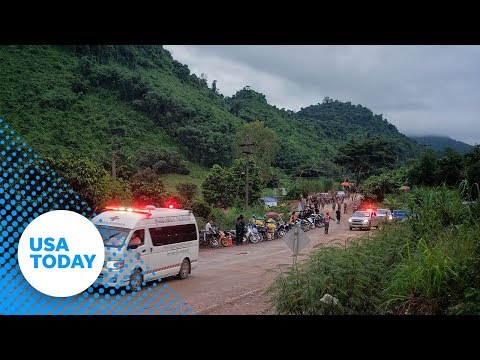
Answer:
[18, 210, 105, 297]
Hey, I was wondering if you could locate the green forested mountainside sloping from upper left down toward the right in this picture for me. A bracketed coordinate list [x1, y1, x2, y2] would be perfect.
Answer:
[0, 45, 421, 183]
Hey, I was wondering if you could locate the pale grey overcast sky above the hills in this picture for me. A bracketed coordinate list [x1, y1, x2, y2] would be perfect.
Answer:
[165, 45, 480, 145]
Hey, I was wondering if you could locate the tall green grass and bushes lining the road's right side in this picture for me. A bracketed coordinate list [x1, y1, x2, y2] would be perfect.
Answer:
[267, 187, 480, 314]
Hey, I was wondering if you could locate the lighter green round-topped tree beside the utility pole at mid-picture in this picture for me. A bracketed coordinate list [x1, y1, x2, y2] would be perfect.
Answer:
[234, 121, 279, 184]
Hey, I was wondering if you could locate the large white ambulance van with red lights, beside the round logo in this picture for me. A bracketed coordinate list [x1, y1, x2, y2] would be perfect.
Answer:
[92, 206, 199, 290]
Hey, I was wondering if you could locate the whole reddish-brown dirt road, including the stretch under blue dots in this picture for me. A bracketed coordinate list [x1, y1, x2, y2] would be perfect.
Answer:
[76, 201, 368, 315]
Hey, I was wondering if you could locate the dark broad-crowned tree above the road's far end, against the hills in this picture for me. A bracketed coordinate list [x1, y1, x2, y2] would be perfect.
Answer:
[334, 139, 397, 187]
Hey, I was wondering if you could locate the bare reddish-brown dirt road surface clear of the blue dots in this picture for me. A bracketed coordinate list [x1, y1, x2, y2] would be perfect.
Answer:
[166, 205, 368, 315]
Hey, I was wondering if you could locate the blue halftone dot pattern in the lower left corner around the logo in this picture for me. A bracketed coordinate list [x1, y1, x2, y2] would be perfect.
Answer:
[0, 119, 191, 315]
